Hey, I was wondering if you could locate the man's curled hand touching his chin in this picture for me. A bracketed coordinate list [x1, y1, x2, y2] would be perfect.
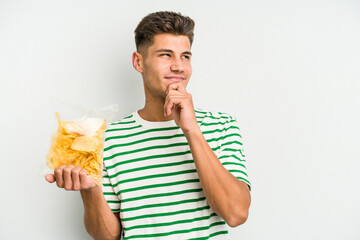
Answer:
[164, 83, 199, 132]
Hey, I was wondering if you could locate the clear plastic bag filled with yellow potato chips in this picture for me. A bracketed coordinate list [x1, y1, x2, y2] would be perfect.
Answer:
[46, 113, 106, 184]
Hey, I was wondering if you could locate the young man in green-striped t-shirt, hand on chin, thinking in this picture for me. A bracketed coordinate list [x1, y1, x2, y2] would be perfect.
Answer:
[46, 12, 250, 239]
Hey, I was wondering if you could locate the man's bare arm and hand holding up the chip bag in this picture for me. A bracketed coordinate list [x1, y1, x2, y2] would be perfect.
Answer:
[45, 165, 121, 240]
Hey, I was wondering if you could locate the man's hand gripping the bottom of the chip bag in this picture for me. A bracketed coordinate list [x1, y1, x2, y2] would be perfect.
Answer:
[45, 165, 97, 191]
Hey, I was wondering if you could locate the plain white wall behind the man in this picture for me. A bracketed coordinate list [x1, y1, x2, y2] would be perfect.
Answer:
[0, 0, 360, 240]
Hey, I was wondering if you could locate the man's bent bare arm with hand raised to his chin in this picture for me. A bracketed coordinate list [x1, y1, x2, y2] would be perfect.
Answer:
[164, 83, 251, 227]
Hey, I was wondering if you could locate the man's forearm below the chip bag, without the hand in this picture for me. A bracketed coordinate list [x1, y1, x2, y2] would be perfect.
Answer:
[80, 186, 121, 240]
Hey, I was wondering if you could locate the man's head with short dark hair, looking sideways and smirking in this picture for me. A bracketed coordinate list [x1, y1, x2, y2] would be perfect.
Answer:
[132, 12, 195, 100]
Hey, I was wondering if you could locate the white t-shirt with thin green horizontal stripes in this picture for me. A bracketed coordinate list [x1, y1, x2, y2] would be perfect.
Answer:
[103, 109, 250, 240]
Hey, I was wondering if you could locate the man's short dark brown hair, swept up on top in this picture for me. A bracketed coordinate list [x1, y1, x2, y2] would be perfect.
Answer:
[134, 11, 195, 51]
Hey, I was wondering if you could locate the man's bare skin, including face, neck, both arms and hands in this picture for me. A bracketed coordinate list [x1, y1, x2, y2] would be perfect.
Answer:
[45, 34, 251, 239]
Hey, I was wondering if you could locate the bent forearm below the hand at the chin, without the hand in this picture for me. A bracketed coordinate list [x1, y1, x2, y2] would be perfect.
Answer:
[185, 129, 250, 227]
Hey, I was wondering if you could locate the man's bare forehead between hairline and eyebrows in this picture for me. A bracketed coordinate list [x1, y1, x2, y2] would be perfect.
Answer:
[149, 33, 191, 52]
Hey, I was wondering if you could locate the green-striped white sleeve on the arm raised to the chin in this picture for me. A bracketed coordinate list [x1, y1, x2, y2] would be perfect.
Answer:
[217, 116, 251, 189]
